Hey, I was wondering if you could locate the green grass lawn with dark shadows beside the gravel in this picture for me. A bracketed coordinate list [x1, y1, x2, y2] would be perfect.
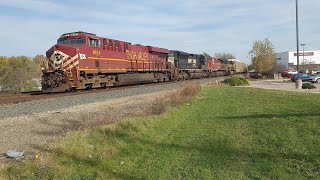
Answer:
[3, 87, 320, 179]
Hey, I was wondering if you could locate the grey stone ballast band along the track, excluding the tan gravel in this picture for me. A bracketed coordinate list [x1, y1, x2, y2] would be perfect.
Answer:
[0, 77, 223, 121]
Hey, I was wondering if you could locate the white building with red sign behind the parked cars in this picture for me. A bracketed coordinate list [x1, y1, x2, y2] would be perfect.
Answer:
[276, 50, 320, 70]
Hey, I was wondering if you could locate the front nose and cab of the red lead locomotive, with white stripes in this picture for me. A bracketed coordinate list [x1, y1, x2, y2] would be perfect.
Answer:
[42, 32, 95, 92]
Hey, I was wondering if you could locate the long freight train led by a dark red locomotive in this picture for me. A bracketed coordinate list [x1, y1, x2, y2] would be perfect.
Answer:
[42, 31, 247, 92]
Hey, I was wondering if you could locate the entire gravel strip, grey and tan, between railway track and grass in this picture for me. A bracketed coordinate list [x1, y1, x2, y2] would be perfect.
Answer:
[0, 77, 224, 167]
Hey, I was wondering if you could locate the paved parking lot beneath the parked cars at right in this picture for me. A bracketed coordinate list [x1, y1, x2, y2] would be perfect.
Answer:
[250, 79, 320, 93]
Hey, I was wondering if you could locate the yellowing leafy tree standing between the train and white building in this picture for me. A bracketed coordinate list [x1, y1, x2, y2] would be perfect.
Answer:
[249, 38, 276, 75]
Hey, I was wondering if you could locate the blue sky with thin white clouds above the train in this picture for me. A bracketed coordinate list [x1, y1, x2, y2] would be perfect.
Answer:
[0, 0, 320, 63]
